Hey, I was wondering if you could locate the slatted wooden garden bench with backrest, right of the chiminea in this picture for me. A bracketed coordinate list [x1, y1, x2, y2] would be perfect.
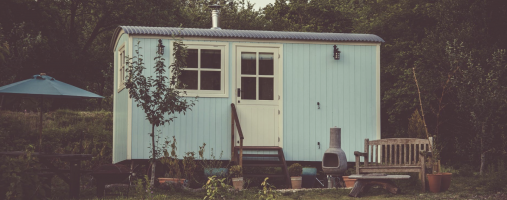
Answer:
[354, 138, 432, 192]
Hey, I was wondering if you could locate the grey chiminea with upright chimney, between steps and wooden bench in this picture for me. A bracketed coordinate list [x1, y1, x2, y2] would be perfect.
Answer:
[322, 127, 347, 188]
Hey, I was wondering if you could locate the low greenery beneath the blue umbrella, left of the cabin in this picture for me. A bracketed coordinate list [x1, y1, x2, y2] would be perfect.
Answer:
[0, 110, 113, 169]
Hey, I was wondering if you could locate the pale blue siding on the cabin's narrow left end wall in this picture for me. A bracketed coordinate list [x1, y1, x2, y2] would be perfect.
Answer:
[113, 34, 129, 163]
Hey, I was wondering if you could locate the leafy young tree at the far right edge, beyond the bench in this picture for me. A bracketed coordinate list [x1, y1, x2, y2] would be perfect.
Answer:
[447, 41, 507, 175]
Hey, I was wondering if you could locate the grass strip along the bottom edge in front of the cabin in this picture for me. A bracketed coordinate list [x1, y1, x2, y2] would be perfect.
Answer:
[46, 175, 507, 199]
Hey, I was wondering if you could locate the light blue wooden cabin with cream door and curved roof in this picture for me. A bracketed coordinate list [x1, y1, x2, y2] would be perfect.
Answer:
[111, 26, 384, 177]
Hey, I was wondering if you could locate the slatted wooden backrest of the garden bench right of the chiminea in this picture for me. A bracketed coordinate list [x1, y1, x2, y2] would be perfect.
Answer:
[364, 137, 432, 166]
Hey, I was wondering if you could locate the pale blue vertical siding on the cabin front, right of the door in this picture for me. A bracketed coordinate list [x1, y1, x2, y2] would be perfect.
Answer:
[283, 44, 377, 162]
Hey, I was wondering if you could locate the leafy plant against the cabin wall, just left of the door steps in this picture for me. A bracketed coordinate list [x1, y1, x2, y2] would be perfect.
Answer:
[199, 143, 228, 178]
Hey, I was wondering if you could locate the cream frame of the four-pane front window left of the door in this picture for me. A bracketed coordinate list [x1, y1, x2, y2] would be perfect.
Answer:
[176, 41, 229, 97]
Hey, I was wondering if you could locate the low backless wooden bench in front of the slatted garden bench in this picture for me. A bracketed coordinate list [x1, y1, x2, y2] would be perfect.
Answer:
[349, 174, 410, 197]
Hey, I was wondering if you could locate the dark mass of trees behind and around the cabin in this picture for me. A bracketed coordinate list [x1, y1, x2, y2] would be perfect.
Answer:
[0, 0, 507, 172]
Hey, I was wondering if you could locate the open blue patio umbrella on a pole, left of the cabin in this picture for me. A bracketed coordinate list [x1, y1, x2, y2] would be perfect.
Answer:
[0, 73, 104, 152]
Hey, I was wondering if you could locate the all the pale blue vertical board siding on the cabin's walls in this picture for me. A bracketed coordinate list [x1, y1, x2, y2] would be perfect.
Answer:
[120, 38, 377, 162]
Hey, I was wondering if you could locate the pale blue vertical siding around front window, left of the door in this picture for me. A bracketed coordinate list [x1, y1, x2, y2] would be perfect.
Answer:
[132, 38, 232, 160]
